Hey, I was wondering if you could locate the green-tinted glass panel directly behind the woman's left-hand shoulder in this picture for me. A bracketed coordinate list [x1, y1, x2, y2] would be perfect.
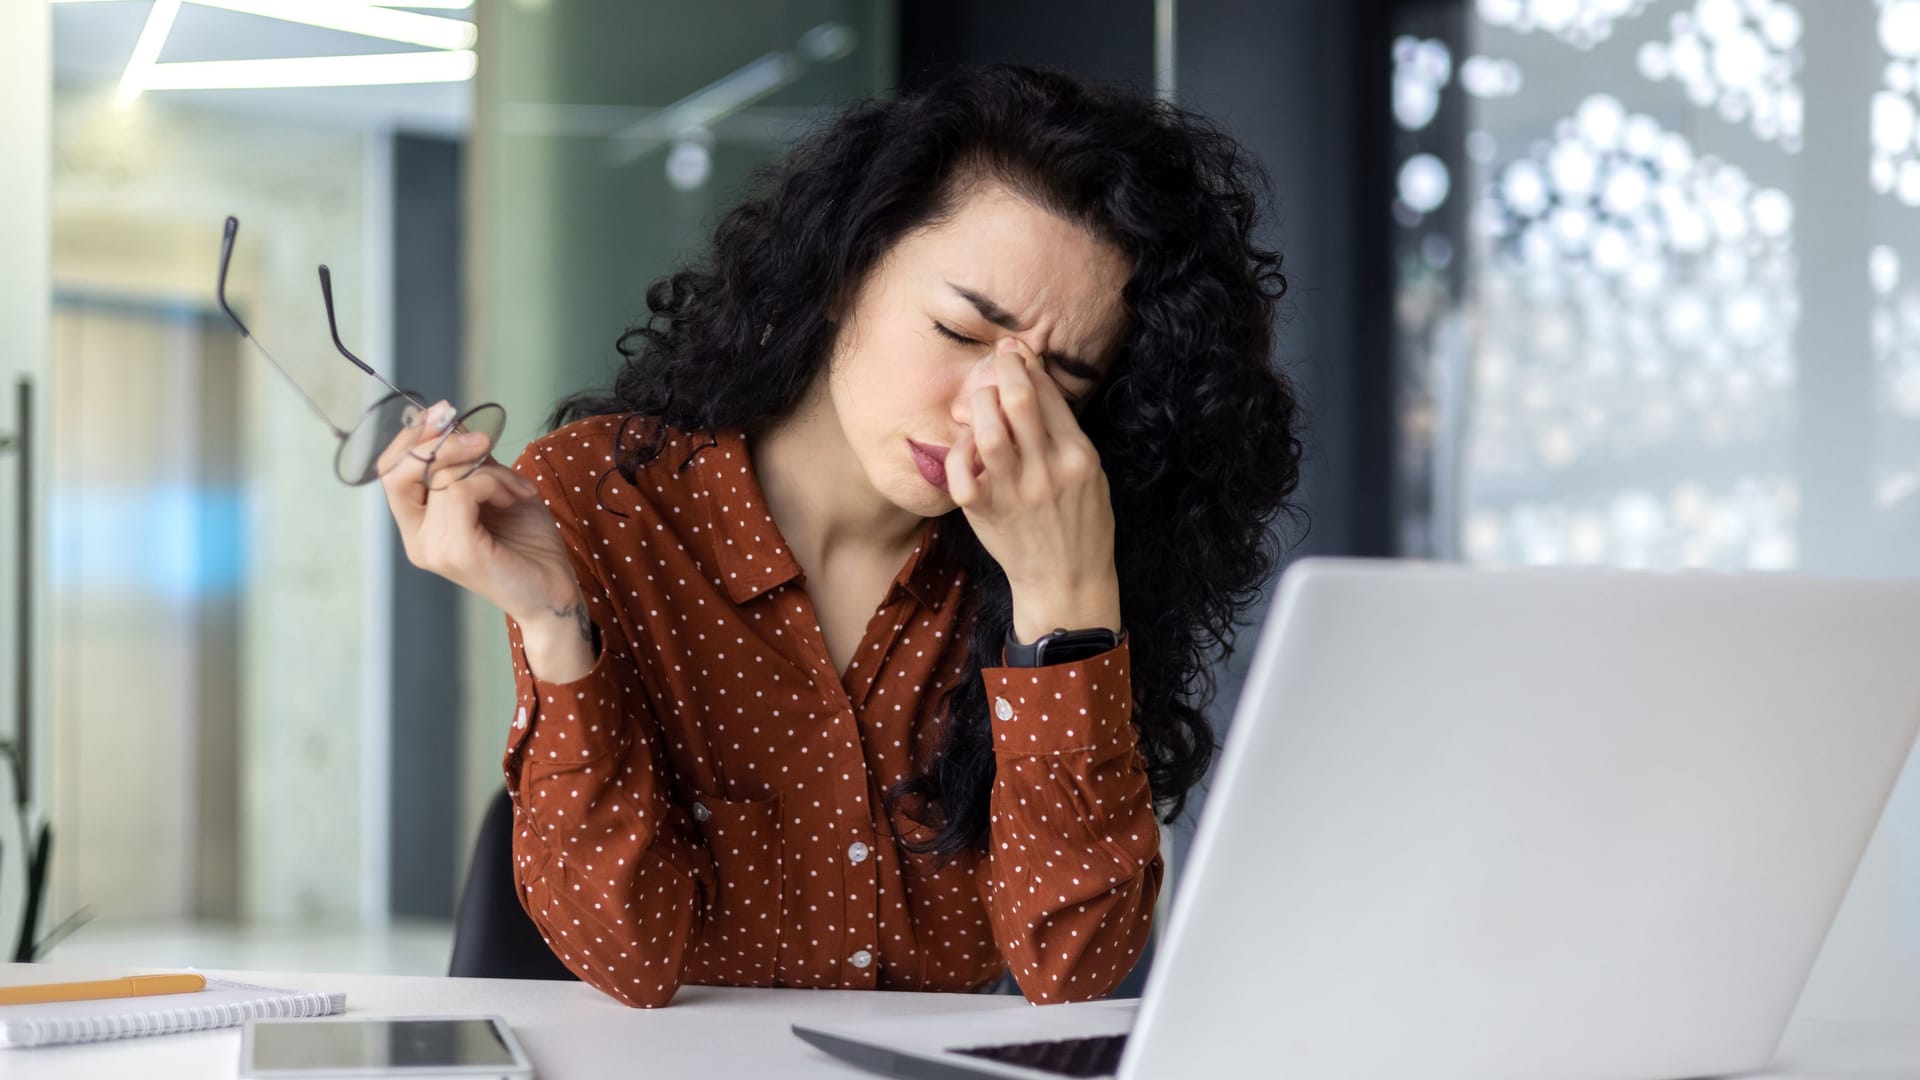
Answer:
[461, 0, 897, 849]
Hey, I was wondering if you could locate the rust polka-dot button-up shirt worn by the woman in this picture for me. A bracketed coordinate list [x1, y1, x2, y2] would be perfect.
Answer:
[503, 417, 1162, 1007]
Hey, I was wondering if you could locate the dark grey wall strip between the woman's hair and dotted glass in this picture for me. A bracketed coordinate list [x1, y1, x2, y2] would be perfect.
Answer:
[1175, 0, 1398, 730]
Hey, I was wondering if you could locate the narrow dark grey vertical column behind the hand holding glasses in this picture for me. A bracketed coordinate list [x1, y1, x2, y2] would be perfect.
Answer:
[388, 135, 466, 919]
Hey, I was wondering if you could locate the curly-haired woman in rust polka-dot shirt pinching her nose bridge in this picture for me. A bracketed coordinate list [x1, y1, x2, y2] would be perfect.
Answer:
[384, 67, 1300, 1007]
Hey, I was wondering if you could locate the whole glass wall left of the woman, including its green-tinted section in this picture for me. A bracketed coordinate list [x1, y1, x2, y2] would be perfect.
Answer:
[30, 0, 895, 972]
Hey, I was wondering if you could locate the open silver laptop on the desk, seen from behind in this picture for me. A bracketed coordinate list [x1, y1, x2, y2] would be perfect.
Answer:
[793, 559, 1920, 1080]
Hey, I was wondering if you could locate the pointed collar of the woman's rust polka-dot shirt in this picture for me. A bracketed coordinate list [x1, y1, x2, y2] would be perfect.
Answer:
[693, 430, 954, 611]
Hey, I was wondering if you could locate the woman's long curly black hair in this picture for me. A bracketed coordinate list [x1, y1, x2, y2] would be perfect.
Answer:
[549, 65, 1302, 857]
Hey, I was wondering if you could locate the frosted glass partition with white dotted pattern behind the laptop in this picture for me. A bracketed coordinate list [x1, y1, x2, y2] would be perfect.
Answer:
[1390, 0, 1920, 1019]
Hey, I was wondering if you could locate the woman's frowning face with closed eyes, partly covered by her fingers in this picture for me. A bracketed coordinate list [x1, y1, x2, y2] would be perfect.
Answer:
[828, 184, 1131, 517]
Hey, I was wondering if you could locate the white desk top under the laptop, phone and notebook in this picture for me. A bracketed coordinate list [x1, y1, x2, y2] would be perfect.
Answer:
[11, 965, 1920, 1080]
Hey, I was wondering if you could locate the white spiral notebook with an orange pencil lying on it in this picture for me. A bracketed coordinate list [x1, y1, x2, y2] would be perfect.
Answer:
[0, 976, 348, 1049]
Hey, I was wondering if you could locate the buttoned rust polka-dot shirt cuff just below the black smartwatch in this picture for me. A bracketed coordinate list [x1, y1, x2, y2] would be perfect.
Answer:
[979, 642, 1137, 753]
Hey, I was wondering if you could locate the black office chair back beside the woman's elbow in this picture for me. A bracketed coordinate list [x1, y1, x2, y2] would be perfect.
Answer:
[447, 788, 580, 978]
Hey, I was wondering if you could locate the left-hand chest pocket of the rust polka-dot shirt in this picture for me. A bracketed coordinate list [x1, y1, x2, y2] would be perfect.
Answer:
[685, 780, 785, 986]
